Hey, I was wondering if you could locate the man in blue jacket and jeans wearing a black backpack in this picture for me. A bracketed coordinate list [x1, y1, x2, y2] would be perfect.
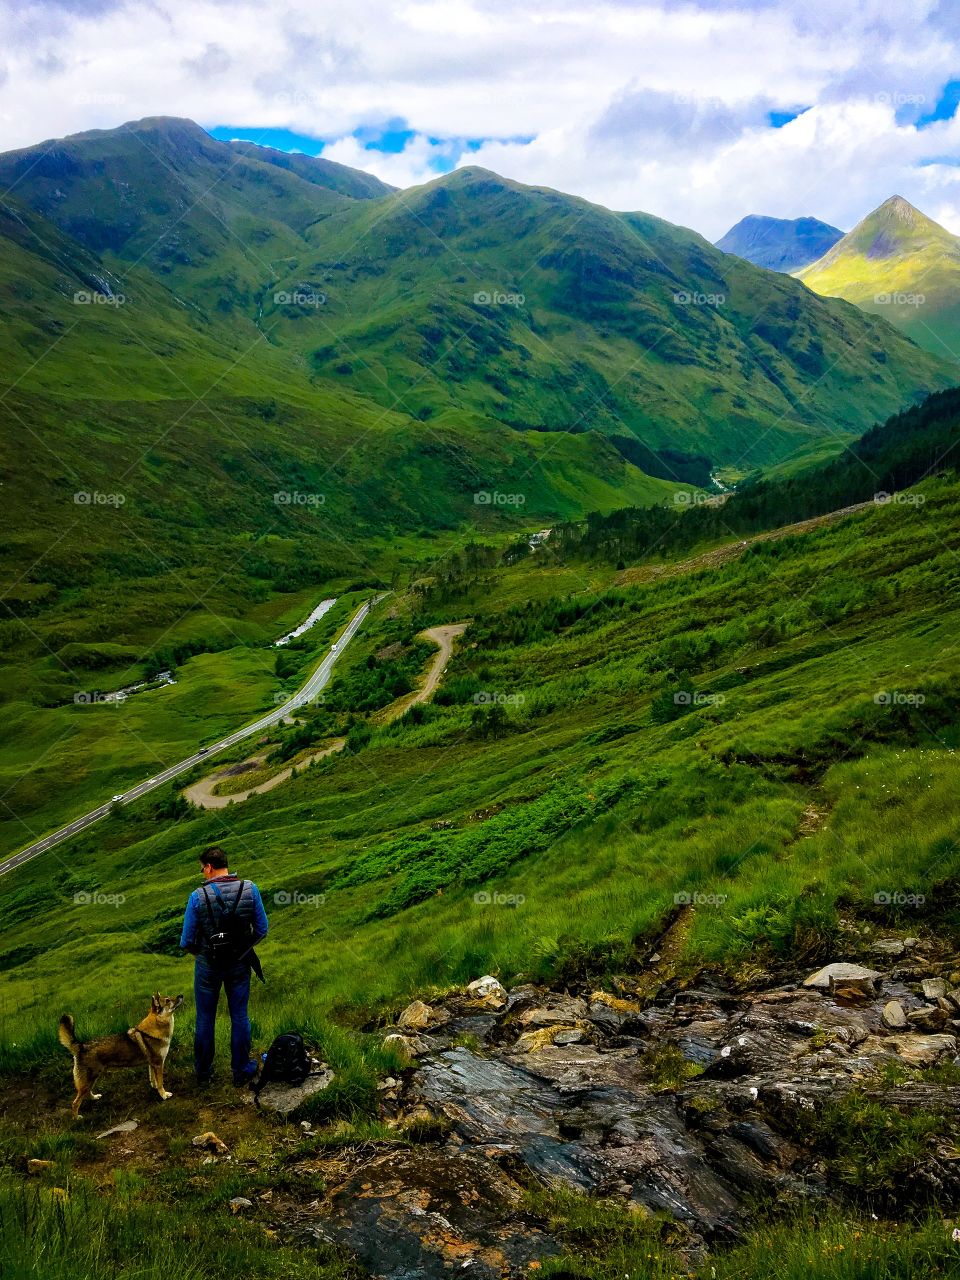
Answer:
[180, 845, 268, 1088]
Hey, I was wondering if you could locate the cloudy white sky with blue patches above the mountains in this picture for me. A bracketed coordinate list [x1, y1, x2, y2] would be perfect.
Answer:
[0, 0, 960, 239]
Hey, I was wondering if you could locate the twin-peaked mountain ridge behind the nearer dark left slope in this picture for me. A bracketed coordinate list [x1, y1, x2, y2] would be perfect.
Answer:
[0, 119, 947, 465]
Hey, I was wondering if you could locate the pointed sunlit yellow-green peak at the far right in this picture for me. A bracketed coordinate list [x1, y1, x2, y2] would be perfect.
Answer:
[796, 196, 960, 361]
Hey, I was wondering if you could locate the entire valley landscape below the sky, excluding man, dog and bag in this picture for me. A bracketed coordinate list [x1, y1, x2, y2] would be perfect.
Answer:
[0, 102, 960, 1280]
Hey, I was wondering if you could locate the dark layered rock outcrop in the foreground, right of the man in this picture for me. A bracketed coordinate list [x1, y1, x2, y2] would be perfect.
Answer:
[289, 940, 960, 1280]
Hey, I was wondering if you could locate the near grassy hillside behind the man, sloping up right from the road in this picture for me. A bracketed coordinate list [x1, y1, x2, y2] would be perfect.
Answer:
[4, 453, 960, 1039]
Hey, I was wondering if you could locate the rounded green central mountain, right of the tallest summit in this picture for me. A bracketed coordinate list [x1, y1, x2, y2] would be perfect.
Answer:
[280, 169, 957, 465]
